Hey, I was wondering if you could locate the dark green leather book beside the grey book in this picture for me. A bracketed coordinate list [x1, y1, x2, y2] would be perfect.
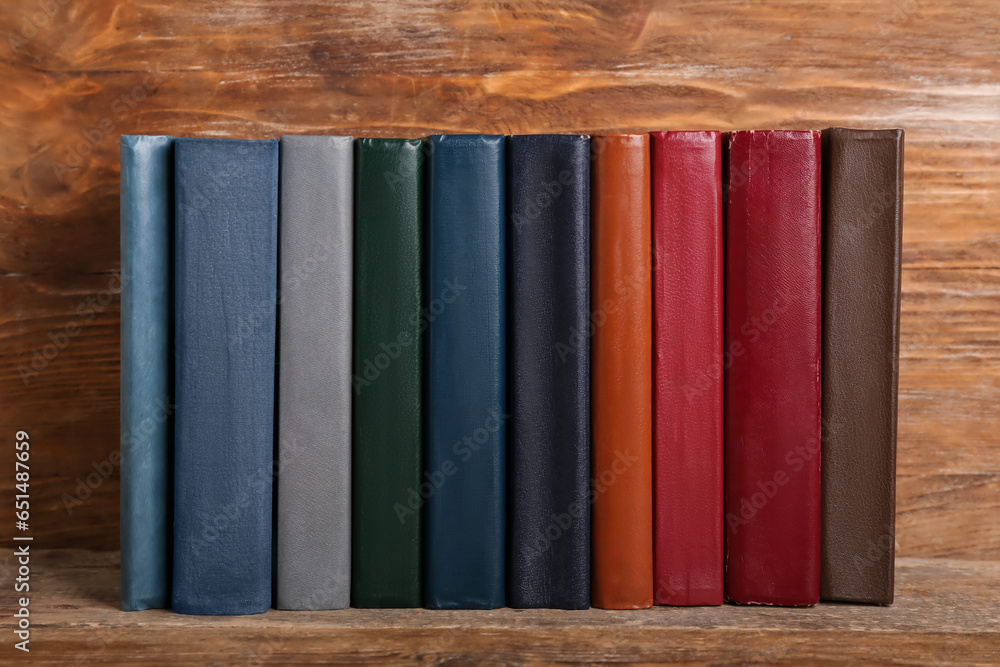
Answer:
[351, 139, 431, 607]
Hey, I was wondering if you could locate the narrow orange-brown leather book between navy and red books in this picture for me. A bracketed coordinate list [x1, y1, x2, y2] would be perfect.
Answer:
[591, 134, 653, 609]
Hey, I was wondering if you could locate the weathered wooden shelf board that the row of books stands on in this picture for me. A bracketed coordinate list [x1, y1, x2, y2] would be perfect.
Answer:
[0, 550, 1000, 665]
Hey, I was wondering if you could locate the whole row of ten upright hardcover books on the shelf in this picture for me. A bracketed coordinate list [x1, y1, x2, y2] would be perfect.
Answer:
[121, 128, 903, 615]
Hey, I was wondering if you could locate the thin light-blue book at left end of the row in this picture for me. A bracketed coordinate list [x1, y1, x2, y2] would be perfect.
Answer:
[120, 135, 174, 611]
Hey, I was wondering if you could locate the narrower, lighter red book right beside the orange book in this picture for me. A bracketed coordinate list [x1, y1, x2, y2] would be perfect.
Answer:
[652, 132, 724, 605]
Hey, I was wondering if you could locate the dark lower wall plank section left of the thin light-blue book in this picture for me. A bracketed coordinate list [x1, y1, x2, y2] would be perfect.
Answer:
[0, 275, 120, 549]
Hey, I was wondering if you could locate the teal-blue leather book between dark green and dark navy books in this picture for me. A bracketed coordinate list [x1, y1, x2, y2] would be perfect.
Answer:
[420, 135, 508, 609]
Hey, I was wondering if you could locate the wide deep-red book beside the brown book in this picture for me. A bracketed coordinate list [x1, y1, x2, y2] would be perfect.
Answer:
[723, 131, 821, 606]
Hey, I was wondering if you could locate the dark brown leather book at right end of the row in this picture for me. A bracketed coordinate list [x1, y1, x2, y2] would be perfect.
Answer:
[820, 128, 903, 604]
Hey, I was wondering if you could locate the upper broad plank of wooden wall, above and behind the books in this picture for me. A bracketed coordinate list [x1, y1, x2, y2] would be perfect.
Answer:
[0, 0, 1000, 273]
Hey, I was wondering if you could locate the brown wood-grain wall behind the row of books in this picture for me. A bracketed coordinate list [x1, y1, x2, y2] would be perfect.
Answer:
[0, 0, 1000, 560]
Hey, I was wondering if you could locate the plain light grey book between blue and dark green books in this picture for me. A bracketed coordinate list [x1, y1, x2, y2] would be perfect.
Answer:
[275, 136, 354, 610]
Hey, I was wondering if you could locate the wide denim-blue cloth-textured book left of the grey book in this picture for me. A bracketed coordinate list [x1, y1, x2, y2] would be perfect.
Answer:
[173, 139, 278, 615]
